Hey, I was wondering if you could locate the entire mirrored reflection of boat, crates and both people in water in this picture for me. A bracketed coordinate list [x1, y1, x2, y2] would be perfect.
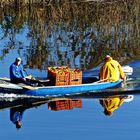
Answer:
[0, 95, 133, 129]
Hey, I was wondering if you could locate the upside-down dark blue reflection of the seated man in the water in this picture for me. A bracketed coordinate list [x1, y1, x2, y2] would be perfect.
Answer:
[10, 108, 26, 129]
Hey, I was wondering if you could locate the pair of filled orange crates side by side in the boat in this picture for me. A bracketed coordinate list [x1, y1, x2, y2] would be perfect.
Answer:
[48, 66, 82, 86]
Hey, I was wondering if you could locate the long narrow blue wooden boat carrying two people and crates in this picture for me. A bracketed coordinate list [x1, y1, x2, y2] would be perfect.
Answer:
[0, 77, 122, 96]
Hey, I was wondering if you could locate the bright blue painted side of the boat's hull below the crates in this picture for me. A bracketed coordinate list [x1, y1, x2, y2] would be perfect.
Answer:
[26, 80, 122, 96]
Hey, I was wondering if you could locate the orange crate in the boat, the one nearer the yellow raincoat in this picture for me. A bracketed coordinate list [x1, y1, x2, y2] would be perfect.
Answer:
[69, 70, 82, 85]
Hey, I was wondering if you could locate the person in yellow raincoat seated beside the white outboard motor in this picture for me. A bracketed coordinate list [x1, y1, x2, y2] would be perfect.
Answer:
[100, 55, 125, 82]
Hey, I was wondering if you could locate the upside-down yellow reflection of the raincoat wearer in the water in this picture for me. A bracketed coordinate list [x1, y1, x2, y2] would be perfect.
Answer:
[100, 97, 124, 116]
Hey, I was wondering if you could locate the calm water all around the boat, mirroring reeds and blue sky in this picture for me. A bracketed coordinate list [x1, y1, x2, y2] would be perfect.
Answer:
[0, 1, 140, 140]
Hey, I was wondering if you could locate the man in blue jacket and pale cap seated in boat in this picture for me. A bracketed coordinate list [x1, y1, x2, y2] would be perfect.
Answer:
[10, 57, 26, 83]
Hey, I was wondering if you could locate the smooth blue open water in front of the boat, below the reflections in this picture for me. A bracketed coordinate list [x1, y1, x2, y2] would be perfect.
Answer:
[0, 97, 140, 140]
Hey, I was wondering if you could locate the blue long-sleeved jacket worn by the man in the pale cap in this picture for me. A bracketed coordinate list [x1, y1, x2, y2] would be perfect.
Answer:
[10, 63, 26, 80]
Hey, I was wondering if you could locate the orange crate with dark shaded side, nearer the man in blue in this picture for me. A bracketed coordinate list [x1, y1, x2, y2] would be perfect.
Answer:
[48, 72, 69, 86]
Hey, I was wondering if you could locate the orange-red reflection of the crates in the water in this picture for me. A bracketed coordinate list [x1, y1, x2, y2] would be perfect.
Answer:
[48, 99, 82, 111]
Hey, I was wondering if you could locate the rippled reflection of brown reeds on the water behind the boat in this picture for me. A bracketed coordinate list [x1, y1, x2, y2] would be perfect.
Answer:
[0, 0, 140, 70]
